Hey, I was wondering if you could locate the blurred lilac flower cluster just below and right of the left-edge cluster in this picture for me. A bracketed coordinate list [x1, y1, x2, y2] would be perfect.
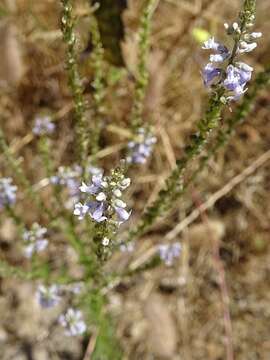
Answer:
[23, 223, 48, 258]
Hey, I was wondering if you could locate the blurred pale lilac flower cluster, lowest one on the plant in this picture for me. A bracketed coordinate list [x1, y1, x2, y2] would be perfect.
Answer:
[59, 308, 86, 336]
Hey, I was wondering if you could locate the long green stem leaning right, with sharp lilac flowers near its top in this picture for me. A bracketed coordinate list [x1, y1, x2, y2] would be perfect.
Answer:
[127, 0, 256, 245]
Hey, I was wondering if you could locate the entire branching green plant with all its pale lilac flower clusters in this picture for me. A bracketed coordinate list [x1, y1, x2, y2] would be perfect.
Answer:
[0, 0, 270, 360]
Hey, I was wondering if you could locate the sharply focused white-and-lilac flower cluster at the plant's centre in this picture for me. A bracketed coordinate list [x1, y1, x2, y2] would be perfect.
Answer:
[74, 173, 131, 225]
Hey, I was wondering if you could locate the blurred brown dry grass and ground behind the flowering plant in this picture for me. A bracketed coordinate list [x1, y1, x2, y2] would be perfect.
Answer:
[0, 0, 270, 360]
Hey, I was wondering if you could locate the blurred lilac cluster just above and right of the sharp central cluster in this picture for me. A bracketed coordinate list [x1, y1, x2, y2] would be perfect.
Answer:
[127, 128, 157, 164]
